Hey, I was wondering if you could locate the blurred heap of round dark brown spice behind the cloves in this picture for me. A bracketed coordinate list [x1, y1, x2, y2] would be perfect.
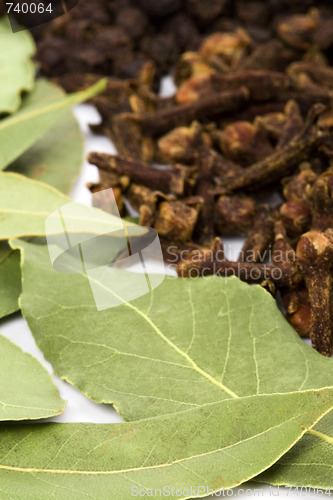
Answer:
[25, 0, 332, 86]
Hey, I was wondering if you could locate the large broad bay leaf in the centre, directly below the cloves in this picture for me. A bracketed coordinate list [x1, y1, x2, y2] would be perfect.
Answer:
[10, 238, 333, 420]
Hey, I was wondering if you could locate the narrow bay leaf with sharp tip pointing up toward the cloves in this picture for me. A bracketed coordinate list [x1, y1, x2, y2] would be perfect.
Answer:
[0, 79, 106, 170]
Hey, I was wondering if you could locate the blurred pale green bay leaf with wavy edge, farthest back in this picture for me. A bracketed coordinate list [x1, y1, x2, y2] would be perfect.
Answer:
[0, 16, 36, 115]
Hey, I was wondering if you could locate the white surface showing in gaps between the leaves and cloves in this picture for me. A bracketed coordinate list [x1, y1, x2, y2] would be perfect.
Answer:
[0, 103, 327, 499]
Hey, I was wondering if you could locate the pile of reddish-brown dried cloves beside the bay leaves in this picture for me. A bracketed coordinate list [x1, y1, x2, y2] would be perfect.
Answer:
[42, 1, 333, 356]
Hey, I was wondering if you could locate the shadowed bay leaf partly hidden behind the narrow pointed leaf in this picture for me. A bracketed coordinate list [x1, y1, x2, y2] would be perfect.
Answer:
[7, 79, 84, 194]
